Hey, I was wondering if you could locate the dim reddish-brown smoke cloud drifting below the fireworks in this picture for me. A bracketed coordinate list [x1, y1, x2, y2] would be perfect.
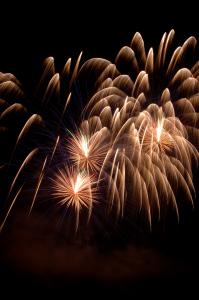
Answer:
[0, 214, 196, 288]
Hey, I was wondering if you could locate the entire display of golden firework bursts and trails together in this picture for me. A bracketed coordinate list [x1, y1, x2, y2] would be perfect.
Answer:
[0, 30, 199, 232]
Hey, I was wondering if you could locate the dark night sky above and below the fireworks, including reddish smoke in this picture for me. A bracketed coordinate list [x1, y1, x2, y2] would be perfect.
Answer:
[0, 1, 199, 299]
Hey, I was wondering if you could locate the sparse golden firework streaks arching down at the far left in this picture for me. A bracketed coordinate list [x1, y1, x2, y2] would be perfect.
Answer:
[0, 54, 81, 229]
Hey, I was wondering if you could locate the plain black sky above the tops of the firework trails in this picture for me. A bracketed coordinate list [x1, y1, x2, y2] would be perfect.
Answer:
[0, 1, 198, 79]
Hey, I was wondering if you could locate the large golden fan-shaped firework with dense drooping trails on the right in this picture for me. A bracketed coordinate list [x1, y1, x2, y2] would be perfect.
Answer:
[79, 30, 199, 224]
